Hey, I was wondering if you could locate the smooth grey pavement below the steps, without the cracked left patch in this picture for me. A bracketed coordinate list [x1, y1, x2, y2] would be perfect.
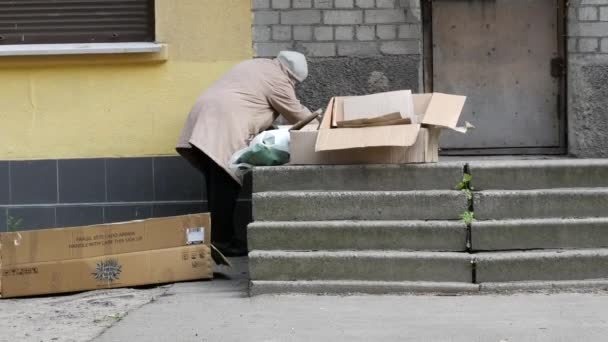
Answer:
[95, 259, 608, 342]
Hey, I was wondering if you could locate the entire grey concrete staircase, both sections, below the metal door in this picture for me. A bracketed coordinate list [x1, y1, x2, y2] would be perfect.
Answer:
[248, 159, 608, 295]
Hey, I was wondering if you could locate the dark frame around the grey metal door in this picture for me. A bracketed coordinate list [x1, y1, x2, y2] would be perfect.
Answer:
[420, 0, 568, 156]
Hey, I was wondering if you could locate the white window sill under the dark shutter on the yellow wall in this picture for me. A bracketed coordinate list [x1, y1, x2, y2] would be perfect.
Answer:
[0, 42, 169, 68]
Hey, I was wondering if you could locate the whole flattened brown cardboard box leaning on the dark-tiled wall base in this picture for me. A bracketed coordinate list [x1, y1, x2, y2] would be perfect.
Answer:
[0, 214, 213, 298]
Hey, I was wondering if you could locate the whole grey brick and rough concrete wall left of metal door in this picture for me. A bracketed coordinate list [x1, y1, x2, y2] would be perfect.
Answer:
[252, 0, 422, 110]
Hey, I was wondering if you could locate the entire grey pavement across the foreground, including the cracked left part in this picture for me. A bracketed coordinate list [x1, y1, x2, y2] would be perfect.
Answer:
[0, 259, 608, 342]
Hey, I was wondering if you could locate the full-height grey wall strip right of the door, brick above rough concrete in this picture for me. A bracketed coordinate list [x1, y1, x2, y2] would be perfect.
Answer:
[568, 0, 608, 157]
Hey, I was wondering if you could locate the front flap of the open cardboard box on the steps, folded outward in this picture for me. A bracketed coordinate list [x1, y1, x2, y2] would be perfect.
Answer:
[315, 125, 420, 151]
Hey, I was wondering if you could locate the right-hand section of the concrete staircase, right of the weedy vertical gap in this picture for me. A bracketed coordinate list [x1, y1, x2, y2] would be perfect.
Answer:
[470, 159, 608, 291]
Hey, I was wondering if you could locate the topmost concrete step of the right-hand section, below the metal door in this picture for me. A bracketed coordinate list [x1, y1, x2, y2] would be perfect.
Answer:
[469, 159, 608, 190]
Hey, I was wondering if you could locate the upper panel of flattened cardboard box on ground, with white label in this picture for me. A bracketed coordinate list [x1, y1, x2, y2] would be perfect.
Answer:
[0, 214, 211, 266]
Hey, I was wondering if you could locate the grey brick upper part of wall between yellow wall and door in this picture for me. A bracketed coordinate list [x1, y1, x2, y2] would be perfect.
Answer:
[252, 0, 422, 57]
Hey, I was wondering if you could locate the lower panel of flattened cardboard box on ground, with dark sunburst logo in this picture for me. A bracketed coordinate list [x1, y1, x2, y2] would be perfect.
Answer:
[0, 245, 213, 298]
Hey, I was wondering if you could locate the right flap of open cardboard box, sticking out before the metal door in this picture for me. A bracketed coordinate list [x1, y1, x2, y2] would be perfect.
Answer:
[422, 93, 466, 130]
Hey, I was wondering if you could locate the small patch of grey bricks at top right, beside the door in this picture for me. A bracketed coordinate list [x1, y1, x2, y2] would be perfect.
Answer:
[568, 0, 608, 55]
